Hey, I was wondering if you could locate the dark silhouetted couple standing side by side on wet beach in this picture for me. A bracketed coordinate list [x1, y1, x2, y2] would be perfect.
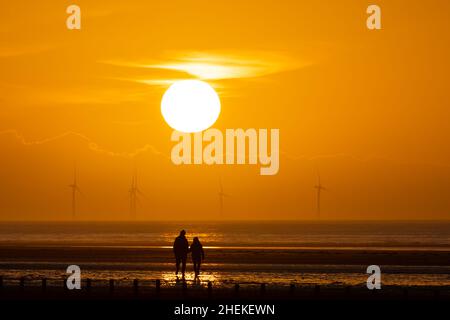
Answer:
[173, 230, 205, 278]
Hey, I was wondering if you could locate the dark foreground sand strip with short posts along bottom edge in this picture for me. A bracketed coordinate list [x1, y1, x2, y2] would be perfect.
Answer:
[0, 286, 450, 301]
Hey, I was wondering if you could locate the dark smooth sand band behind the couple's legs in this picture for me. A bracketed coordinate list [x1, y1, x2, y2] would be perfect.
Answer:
[0, 246, 450, 266]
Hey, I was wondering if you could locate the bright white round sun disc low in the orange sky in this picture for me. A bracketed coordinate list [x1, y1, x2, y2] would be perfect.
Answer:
[161, 80, 220, 132]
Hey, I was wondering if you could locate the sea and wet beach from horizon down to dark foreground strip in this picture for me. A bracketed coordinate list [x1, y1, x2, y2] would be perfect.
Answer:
[0, 222, 450, 286]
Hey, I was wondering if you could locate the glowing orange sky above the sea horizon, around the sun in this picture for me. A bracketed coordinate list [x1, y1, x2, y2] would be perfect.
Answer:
[0, 0, 450, 220]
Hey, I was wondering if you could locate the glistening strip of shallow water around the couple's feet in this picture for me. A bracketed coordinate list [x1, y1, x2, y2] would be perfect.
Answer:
[2, 266, 450, 287]
